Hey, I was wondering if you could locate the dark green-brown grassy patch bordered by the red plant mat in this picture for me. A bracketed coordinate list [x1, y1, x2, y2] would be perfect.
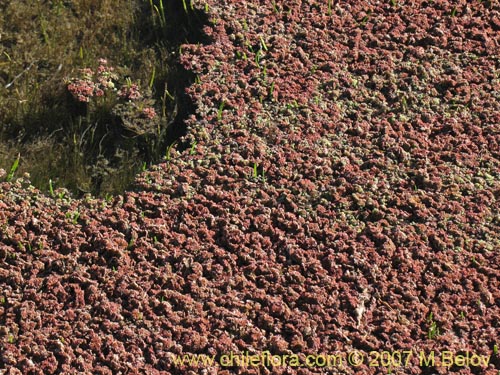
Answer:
[0, 0, 207, 196]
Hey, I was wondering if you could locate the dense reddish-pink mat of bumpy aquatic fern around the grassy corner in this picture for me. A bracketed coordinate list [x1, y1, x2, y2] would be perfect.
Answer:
[0, 0, 500, 375]
